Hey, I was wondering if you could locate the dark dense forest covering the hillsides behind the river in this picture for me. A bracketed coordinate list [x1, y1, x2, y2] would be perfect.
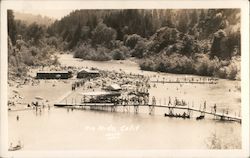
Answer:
[8, 9, 241, 79]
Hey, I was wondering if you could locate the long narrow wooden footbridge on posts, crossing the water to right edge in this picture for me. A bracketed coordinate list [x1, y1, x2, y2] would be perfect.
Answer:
[54, 103, 241, 123]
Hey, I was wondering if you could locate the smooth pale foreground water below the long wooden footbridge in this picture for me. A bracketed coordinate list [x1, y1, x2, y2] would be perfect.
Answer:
[9, 108, 241, 150]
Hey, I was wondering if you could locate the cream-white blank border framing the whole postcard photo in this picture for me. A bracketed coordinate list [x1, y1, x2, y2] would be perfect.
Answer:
[0, 0, 249, 158]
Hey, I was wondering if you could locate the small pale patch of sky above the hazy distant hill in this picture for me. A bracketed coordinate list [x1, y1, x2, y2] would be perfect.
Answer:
[15, 9, 73, 20]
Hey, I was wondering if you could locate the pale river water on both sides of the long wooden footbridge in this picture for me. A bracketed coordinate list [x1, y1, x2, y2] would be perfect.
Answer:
[8, 55, 241, 150]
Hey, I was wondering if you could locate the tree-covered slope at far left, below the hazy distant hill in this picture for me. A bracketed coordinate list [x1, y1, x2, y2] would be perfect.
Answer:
[8, 10, 58, 79]
